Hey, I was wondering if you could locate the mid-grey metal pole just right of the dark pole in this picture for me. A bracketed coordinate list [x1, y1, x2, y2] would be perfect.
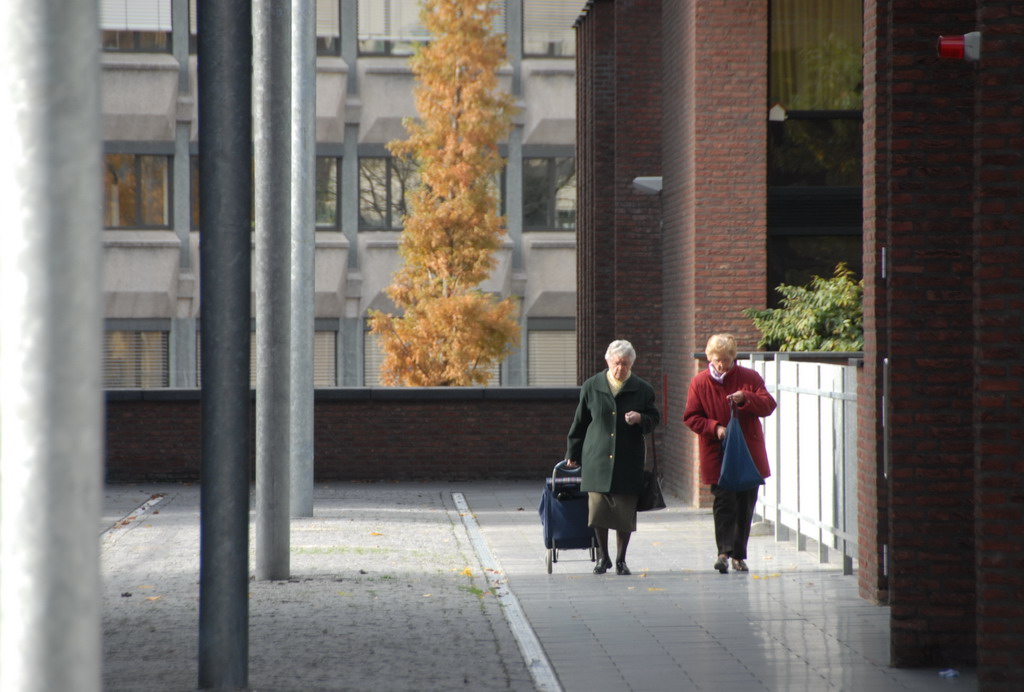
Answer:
[253, 0, 292, 579]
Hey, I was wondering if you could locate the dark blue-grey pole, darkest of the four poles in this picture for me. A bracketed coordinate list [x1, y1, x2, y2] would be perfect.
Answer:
[197, 0, 252, 689]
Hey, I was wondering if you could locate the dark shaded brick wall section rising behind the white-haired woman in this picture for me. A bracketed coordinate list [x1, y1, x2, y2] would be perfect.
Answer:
[577, 0, 662, 384]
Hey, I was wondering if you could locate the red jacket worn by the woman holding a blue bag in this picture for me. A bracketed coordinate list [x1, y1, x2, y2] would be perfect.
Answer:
[683, 365, 776, 485]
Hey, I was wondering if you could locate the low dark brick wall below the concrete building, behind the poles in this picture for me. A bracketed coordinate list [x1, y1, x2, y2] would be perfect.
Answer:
[106, 387, 580, 482]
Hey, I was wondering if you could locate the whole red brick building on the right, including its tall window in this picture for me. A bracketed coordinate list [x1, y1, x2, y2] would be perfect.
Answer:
[578, 0, 1024, 679]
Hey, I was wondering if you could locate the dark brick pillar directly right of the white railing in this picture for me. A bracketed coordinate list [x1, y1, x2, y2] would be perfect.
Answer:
[858, 0, 975, 665]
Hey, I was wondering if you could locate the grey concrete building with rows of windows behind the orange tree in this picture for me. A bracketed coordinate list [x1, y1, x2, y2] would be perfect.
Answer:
[100, 0, 582, 388]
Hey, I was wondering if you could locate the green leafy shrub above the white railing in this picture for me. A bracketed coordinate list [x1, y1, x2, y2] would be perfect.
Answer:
[743, 263, 864, 351]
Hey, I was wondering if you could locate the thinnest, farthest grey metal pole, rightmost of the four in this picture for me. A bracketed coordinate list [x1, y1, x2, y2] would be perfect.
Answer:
[290, 0, 316, 517]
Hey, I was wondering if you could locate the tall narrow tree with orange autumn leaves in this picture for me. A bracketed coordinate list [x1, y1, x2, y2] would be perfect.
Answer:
[371, 0, 519, 386]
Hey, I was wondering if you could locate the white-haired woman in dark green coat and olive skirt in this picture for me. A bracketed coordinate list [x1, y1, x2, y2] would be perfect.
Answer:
[565, 340, 662, 574]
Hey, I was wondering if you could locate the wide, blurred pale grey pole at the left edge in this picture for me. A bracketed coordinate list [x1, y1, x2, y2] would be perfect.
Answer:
[0, 5, 103, 692]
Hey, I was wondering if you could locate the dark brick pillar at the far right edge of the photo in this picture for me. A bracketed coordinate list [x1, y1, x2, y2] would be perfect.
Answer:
[966, 0, 1024, 690]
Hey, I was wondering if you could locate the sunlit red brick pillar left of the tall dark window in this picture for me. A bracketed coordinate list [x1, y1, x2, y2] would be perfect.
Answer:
[662, 0, 768, 503]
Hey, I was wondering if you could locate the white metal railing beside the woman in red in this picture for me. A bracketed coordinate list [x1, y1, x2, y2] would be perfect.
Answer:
[740, 353, 860, 574]
